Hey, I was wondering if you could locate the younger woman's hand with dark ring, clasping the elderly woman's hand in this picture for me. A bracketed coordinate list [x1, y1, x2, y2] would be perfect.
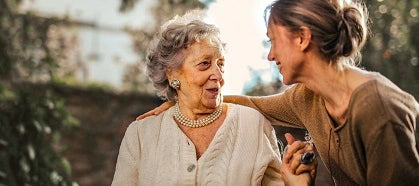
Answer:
[282, 133, 318, 180]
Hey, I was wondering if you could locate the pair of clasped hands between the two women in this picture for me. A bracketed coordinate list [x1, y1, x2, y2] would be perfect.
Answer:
[281, 133, 317, 185]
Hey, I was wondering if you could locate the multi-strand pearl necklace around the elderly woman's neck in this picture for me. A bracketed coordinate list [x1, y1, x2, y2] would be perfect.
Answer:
[173, 103, 223, 128]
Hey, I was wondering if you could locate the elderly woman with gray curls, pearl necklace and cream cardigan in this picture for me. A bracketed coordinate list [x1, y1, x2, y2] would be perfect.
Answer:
[112, 12, 311, 186]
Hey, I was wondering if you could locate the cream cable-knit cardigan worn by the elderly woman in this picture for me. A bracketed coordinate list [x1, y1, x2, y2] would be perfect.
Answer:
[112, 104, 283, 186]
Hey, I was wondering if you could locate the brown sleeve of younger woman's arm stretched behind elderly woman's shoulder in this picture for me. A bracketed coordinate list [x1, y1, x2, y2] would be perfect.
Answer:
[224, 85, 304, 128]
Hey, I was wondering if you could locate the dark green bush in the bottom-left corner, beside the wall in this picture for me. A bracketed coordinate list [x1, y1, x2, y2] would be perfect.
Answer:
[0, 86, 78, 186]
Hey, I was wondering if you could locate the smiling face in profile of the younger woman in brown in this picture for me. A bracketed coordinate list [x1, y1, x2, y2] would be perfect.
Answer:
[267, 21, 304, 85]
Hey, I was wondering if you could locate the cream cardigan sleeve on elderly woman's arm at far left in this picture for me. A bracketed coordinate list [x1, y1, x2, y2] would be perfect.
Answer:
[112, 122, 140, 186]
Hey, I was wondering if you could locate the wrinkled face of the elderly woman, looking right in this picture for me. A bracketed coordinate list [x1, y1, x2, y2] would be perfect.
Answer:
[173, 41, 224, 109]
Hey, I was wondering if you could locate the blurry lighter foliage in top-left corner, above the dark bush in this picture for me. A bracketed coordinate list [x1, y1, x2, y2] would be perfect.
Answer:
[0, 0, 77, 81]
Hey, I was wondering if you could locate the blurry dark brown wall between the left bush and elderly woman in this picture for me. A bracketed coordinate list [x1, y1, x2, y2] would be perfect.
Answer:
[52, 87, 161, 186]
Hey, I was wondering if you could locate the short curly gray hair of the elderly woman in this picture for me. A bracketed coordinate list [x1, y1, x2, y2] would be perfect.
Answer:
[146, 11, 224, 101]
